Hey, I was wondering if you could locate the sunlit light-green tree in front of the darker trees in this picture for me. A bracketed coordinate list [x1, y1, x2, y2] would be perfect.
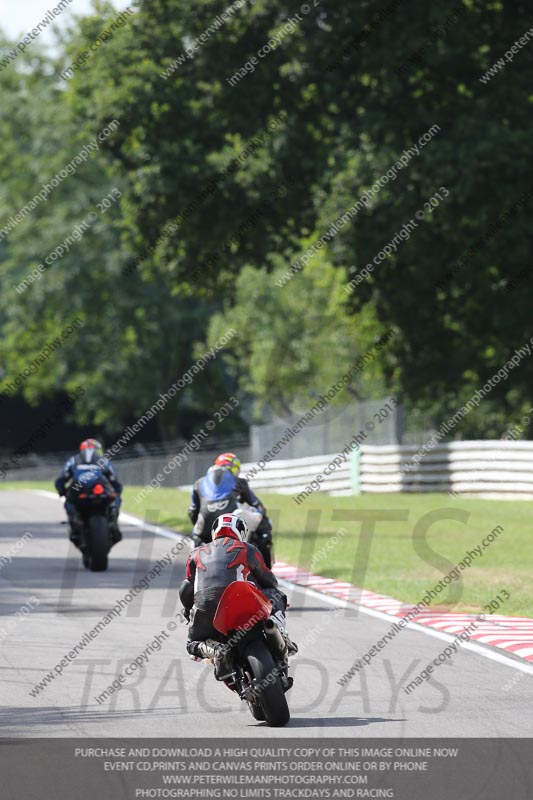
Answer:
[204, 255, 387, 420]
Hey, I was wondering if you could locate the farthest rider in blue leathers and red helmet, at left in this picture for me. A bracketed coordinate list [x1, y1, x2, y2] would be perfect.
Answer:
[55, 439, 122, 548]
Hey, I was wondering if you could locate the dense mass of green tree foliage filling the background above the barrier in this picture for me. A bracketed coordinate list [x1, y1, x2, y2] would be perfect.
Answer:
[0, 0, 533, 437]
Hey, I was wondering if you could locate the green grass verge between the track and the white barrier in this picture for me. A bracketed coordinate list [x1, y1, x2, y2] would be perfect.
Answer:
[2, 483, 533, 617]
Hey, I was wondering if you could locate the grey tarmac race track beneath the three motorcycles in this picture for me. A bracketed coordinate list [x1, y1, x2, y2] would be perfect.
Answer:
[0, 491, 533, 739]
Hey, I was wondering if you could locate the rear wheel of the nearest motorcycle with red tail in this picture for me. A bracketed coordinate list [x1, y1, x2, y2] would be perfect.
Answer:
[246, 640, 291, 728]
